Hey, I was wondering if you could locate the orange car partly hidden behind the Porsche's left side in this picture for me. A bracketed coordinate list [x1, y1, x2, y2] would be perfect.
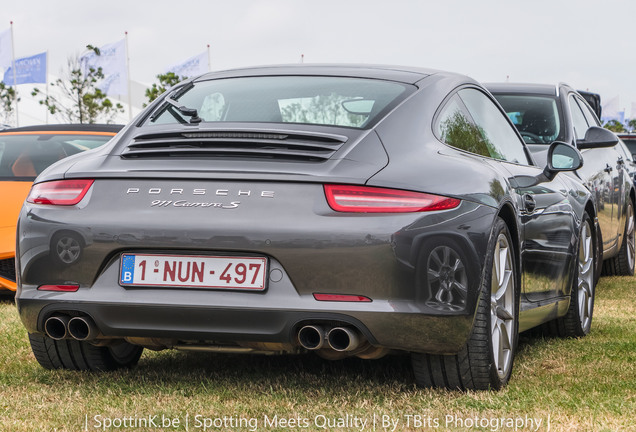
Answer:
[0, 124, 123, 291]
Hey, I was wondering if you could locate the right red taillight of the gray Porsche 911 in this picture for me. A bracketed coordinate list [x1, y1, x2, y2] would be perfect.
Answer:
[325, 185, 460, 213]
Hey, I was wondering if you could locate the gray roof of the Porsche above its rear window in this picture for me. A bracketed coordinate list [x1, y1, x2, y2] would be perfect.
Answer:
[195, 64, 461, 84]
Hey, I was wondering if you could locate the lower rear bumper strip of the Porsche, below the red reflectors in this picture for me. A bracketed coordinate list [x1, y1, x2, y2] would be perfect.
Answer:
[20, 299, 473, 354]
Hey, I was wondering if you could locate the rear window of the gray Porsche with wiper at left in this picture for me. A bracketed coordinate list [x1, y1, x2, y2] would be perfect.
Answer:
[149, 76, 415, 129]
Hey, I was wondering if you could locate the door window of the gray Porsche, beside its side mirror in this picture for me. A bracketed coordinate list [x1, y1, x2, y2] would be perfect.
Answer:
[458, 88, 529, 165]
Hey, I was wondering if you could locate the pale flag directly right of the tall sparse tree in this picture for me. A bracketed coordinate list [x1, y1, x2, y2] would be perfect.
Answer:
[80, 39, 128, 95]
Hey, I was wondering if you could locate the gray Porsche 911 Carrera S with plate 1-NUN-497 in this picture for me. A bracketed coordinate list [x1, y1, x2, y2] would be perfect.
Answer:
[16, 65, 598, 389]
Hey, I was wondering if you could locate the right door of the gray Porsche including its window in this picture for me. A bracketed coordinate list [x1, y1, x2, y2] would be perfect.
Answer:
[458, 89, 578, 302]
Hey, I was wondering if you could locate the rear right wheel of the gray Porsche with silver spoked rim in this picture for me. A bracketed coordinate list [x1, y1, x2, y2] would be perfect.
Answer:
[411, 218, 520, 390]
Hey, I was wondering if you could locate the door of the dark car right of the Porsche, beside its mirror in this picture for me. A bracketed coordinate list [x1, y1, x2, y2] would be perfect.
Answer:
[567, 93, 624, 253]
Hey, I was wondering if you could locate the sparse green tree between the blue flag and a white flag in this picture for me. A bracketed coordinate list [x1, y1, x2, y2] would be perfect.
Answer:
[31, 45, 124, 123]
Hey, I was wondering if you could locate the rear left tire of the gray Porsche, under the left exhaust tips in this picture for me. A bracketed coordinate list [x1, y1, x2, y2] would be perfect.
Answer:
[29, 334, 143, 372]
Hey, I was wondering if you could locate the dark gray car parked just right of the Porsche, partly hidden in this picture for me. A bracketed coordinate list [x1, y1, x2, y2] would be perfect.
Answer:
[487, 83, 636, 275]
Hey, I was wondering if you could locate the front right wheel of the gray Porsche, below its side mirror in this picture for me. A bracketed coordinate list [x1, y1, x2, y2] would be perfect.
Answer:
[544, 213, 598, 337]
